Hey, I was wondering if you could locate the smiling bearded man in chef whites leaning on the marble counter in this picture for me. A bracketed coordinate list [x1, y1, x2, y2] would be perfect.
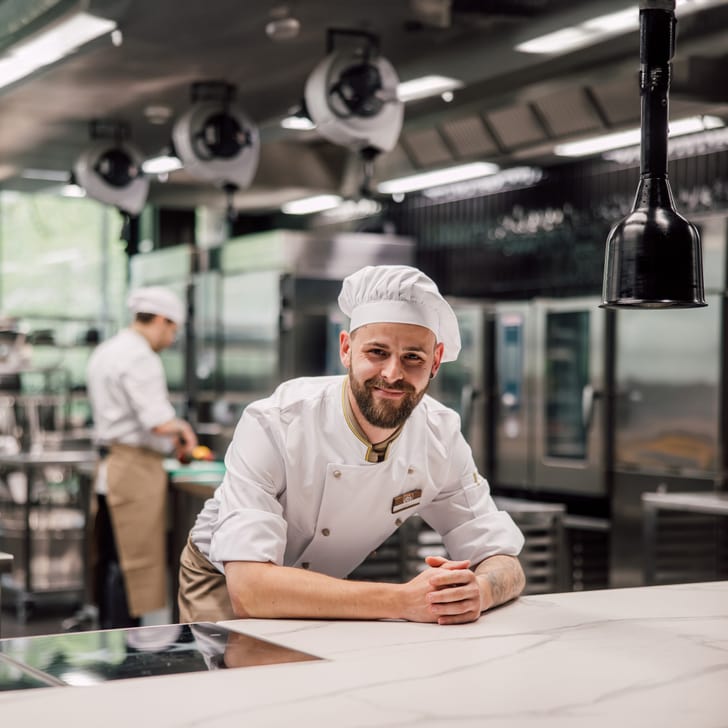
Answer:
[179, 266, 524, 624]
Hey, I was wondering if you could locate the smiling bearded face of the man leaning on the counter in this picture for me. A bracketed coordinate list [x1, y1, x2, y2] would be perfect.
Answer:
[339, 323, 443, 442]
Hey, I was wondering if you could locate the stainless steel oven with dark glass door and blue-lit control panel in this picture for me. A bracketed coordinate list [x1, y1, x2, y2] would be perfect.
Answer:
[493, 298, 605, 495]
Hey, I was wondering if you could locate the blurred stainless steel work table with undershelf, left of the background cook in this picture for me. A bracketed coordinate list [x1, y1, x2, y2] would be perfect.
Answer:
[0, 449, 98, 621]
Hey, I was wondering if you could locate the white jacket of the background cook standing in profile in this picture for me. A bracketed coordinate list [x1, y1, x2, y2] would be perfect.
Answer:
[86, 329, 176, 453]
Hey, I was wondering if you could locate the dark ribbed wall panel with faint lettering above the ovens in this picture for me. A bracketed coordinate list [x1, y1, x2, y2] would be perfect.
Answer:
[386, 151, 728, 300]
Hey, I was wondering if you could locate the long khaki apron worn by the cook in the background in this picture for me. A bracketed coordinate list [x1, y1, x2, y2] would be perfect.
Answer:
[106, 444, 167, 617]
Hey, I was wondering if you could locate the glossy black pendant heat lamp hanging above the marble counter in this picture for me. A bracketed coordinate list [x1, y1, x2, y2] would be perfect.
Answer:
[601, 0, 706, 309]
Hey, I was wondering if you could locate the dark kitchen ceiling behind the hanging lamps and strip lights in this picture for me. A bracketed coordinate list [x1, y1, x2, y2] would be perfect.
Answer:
[0, 0, 728, 210]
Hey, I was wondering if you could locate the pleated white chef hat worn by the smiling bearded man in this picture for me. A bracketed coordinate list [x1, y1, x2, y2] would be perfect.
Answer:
[339, 265, 460, 361]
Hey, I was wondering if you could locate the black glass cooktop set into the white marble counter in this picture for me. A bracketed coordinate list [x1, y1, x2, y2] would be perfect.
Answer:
[0, 622, 320, 690]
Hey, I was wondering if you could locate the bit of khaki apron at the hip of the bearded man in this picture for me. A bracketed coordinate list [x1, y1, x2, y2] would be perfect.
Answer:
[177, 538, 237, 622]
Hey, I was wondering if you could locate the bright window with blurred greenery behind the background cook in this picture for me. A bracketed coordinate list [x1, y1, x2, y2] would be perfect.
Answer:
[0, 191, 127, 426]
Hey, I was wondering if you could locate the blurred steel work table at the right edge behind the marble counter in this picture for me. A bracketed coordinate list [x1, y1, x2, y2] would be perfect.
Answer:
[642, 491, 728, 584]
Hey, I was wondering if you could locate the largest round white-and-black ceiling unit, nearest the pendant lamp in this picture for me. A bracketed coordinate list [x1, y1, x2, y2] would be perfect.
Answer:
[304, 28, 404, 195]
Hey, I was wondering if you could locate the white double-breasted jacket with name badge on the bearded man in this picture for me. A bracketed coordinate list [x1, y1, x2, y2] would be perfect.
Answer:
[191, 376, 523, 577]
